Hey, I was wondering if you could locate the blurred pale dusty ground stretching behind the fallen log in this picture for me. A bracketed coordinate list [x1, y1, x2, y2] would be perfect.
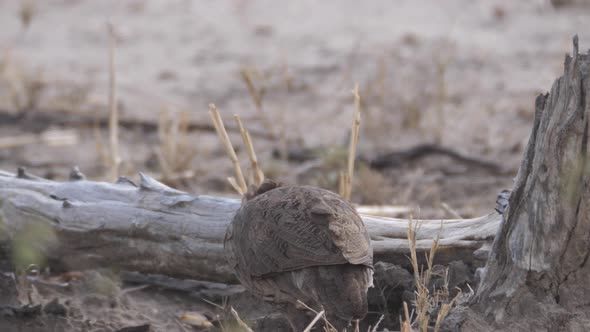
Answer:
[0, 0, 590, 331]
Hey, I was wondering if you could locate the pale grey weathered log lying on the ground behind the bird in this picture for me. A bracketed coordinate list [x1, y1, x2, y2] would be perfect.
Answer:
[0, 169, 501, 283]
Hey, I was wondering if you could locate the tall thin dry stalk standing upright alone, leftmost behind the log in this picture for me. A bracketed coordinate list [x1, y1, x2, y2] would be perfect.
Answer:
[108, 24, 121, 179]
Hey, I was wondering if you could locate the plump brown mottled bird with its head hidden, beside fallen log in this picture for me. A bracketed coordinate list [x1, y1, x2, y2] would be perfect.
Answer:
[224, 180, 373, 331]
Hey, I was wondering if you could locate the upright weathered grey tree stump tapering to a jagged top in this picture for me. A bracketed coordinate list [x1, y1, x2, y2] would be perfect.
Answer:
[463, 37, 590, 331]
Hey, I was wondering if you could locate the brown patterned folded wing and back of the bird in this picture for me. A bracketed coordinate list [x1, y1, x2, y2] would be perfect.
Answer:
[226, 186, 373, 277]
